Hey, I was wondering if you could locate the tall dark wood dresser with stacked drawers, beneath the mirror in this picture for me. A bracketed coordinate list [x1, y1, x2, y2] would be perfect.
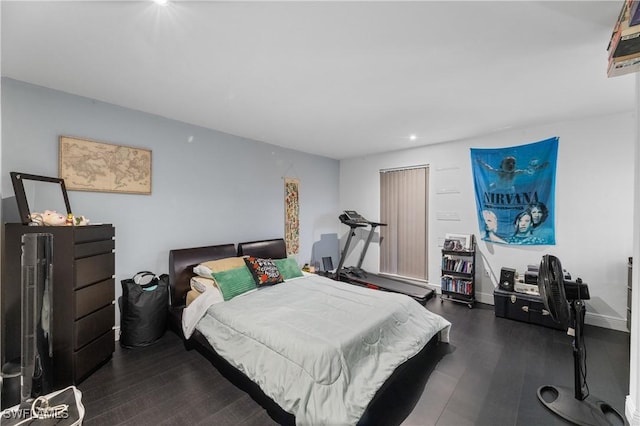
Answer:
[1, 223, 115, 388]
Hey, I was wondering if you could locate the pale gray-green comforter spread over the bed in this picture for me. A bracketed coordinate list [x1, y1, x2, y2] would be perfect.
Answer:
[197, 275, 451, 425]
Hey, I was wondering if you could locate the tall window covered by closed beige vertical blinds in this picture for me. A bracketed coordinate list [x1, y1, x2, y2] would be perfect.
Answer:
[380, 166, 429, 281]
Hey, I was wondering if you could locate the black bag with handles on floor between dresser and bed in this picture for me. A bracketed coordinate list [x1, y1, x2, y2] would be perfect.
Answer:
[118, 271, 169, 347]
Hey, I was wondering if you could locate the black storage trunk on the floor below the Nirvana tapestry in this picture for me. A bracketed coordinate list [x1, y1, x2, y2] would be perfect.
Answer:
[493, 288, 564, 330]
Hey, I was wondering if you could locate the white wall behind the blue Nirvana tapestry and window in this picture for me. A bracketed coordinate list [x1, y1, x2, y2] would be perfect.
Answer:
[340, 112, 636, 331]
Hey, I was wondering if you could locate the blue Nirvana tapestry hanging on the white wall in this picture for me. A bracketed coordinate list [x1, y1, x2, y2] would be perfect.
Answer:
[471, 137, 558, 245]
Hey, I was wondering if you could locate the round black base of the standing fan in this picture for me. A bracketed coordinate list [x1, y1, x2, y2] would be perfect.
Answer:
[538, 385, 625, 426]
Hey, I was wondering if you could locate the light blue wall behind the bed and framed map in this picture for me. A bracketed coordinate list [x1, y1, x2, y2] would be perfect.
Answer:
[0, 78, 340, 322]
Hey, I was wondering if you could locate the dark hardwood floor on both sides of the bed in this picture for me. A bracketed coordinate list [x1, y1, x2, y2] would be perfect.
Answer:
[78, 298, 629, 426]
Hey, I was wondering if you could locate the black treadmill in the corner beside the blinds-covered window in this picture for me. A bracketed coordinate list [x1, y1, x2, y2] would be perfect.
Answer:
[334, 210, 434, 305]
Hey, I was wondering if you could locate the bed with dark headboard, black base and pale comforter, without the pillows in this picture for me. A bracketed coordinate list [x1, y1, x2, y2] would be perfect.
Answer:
[169, 239, 450, 424]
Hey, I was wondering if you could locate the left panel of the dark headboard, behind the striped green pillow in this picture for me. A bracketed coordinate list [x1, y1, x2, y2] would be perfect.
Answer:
[169, 244, 236, 307]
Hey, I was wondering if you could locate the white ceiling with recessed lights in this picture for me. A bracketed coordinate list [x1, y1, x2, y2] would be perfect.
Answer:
[0, 0, 635, 159]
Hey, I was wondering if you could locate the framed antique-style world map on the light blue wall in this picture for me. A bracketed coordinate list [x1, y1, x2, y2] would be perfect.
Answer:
[58, 136, 151, 194]
